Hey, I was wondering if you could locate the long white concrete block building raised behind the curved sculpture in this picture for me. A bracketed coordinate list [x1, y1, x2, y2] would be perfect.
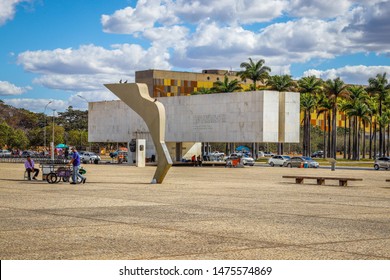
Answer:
[88, 91, 300, 160]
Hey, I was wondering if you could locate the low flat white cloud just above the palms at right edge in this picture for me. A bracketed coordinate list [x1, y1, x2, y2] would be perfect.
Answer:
[303, 65, 390, 85]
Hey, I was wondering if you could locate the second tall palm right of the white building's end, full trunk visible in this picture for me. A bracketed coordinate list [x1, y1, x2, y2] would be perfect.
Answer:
[325, 77, 347, 159]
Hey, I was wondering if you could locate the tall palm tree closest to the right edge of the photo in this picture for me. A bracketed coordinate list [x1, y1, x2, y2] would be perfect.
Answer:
[367, 73, 390, 156]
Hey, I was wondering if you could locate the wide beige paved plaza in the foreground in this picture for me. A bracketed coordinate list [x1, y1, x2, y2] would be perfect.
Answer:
[0, 163, 390, 260]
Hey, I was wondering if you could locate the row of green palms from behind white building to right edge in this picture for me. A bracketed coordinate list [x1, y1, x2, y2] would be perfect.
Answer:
[192, 58, 390, 160]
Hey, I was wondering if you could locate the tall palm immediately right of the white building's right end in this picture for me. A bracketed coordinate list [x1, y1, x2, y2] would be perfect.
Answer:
[298, 76, 322, 156]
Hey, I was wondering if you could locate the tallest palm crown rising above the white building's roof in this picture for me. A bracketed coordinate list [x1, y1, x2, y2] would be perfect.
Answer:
[237, 58, 271, 90]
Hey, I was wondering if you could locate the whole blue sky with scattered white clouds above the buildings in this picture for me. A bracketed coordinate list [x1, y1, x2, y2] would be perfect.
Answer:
[0, 0, 390, 113]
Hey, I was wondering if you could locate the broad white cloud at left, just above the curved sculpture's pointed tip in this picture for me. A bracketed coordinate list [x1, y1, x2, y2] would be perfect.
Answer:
[17, 44, 170, 91]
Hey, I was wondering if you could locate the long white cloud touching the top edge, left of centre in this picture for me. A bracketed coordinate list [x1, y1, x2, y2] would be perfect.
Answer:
[101, 0, 288, 34]
